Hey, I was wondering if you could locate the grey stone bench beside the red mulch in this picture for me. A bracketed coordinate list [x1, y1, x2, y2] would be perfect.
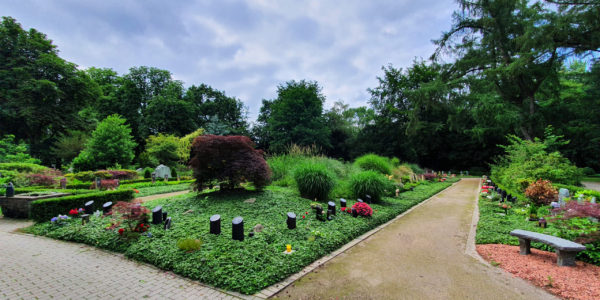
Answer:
[510, 229, 586, 266]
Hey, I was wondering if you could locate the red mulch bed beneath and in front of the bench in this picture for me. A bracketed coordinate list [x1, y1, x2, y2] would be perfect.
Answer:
[477, 244, 600, 299]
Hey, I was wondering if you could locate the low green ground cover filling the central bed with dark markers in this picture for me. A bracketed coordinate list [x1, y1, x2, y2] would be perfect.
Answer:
[27, 180, 455, 294]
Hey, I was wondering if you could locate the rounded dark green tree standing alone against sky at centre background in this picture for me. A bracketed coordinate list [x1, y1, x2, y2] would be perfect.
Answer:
[263, 80, 331, 153]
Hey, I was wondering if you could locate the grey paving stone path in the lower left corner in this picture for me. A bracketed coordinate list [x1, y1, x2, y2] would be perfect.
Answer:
[0, 192, 244, 299]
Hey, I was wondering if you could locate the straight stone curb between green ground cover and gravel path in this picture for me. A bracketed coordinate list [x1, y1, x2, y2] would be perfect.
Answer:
[253, 179, 462, 299]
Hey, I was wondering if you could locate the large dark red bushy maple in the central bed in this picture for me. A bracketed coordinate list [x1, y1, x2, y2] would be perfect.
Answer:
[190, 135, 271, 190]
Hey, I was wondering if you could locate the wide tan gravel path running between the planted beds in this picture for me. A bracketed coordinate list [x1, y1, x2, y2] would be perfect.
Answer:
[276, 179, 555, 299]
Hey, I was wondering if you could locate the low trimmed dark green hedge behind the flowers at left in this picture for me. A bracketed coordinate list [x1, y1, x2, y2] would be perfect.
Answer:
[29, 190, 133, 222]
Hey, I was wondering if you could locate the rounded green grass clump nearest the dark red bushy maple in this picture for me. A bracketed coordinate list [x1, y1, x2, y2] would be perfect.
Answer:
[294, 161, 335, 201]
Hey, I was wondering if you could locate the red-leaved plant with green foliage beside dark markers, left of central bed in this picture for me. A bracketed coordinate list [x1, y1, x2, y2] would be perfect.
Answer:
[112, 201, 150, 239]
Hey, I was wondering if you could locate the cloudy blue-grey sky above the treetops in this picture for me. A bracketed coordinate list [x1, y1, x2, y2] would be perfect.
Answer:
[0, 0, 457, 120]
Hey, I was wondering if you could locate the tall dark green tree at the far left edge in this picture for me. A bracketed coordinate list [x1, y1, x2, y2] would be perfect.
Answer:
[0, 17, 99, 164]
